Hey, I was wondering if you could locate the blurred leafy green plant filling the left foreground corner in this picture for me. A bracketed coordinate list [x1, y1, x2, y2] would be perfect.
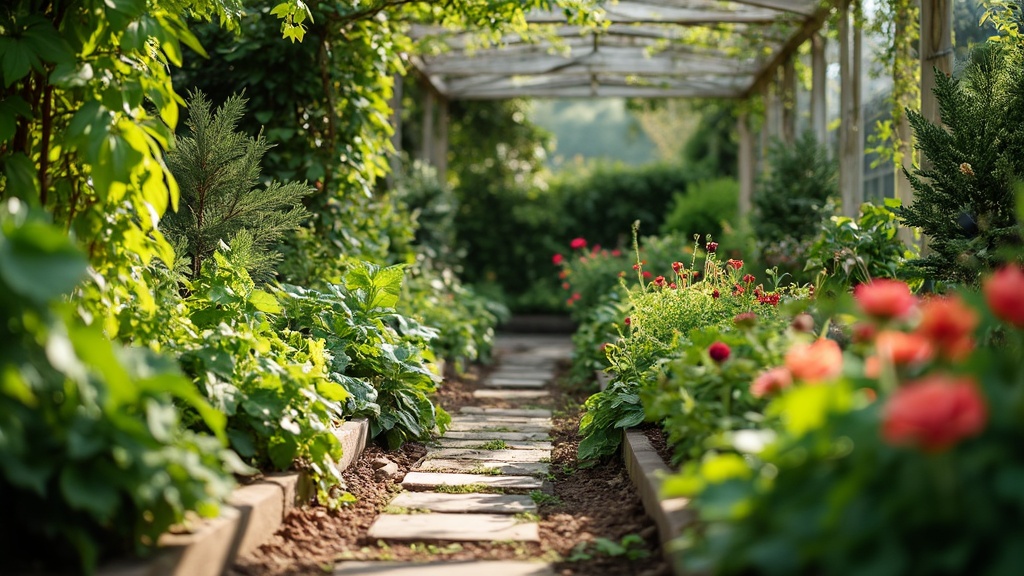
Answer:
[0, 200, 239, 573]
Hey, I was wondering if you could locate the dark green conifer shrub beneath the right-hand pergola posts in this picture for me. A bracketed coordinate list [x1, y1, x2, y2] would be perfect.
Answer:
[752, 132, 839, 243]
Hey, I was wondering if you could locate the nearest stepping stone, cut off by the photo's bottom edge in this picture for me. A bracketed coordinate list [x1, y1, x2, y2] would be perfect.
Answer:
[334, 560, 555, 576]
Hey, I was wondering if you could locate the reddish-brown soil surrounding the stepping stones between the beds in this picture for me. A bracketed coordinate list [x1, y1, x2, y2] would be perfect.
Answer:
[229, 350, 670, 576]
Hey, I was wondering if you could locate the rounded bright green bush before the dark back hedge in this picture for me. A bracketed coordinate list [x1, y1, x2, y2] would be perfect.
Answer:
[662, 178, 739, 243]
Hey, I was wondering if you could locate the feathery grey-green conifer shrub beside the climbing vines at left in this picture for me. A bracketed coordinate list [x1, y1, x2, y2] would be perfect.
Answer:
[160, 92, 312, 279]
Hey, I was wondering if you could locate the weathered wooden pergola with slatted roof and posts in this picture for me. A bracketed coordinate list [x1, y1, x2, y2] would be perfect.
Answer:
[395, 0, 952, 215]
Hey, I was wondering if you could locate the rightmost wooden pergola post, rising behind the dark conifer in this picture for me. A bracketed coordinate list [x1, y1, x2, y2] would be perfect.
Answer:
[920, 0, 953, 143]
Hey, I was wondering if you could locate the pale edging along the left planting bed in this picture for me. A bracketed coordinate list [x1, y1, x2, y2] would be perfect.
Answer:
[97, 418, 370, 576]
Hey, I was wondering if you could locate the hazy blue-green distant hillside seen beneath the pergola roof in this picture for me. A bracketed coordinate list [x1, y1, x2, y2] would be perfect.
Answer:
[530, 98, 658, 170]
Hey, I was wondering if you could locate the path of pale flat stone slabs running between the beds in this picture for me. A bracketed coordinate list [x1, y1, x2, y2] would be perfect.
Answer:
[334, 335, 572, 576]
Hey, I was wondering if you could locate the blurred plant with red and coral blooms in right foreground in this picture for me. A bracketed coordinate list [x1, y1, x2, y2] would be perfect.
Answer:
[666, 266, 1024, 576]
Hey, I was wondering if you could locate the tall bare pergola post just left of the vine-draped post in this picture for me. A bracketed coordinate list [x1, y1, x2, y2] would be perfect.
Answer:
[839, 0, 864, 217]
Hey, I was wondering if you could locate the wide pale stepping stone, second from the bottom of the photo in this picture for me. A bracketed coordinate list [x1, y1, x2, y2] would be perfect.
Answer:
[367, 513, 541, 542]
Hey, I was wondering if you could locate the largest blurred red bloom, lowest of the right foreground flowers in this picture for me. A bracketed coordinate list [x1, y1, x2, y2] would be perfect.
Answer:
[882, 374, 988, 452]
